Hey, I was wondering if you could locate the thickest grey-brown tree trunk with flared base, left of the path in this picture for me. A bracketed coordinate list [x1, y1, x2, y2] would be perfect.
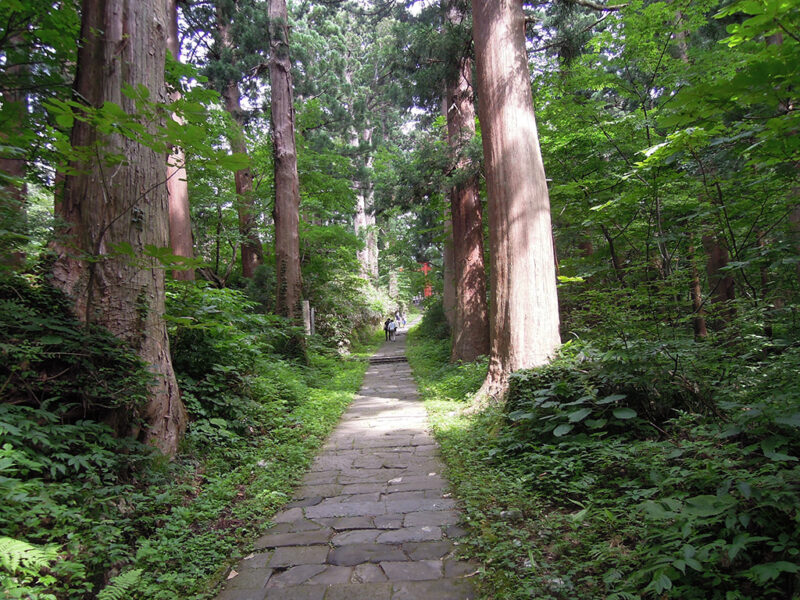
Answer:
[53, 0, 186, 454]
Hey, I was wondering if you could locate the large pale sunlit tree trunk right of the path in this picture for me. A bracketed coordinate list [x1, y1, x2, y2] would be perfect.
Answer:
[472, 0, 561, 395]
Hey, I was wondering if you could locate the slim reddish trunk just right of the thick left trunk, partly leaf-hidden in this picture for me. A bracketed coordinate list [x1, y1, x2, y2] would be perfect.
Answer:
[167, 0, 194, 281]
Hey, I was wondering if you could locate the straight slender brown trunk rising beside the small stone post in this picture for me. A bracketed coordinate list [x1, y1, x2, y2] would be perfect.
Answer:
[269, 0, 302, 319]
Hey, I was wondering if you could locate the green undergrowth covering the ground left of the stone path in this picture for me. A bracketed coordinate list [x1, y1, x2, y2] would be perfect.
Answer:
[0, 275, 381, 600]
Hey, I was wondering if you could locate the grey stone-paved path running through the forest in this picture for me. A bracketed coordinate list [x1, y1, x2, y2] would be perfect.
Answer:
[217, 330, 477, 600]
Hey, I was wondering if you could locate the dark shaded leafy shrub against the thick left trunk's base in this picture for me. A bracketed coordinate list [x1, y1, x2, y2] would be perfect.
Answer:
[0, 273, 150, 423]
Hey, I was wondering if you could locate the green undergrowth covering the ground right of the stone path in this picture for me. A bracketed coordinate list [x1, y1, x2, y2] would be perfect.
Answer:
[409, 316, 800, 600]
